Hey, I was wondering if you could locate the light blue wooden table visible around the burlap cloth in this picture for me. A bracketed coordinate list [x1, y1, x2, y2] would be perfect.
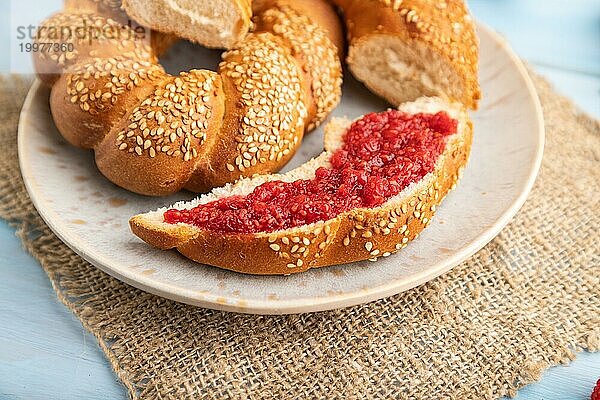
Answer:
[0, 0, 600, 400]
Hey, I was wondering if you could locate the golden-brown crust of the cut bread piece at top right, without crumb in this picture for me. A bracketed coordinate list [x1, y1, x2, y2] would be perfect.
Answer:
[334, 0, 481, 109]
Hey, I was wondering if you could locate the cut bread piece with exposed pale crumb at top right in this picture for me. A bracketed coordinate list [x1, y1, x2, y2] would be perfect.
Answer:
[334, 0, 481, 109]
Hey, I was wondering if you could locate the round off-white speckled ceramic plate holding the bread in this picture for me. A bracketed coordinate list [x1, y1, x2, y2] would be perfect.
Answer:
[19, 26, 544, 314]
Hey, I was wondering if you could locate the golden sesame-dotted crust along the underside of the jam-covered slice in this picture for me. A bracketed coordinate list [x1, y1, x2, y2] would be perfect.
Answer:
[130, 99, 473, 275]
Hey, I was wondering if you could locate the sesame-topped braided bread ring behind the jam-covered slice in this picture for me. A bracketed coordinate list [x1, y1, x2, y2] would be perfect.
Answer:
[35, 0, 342, 196]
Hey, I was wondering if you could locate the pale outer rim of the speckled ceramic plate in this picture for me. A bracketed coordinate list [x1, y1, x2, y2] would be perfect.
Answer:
[17, 22, 545, 315]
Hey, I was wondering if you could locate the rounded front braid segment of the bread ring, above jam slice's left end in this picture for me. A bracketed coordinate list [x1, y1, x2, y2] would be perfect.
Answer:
[96, 70, 224, 196]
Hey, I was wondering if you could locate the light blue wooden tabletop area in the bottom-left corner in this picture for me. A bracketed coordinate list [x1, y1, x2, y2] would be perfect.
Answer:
[0, 221, 127, 400]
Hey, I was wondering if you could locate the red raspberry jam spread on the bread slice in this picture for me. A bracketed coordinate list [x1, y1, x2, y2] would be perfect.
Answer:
[164, 110, 458, 234]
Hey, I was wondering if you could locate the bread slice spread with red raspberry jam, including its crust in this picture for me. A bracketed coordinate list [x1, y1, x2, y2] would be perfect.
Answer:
[130, 98, 472, 274]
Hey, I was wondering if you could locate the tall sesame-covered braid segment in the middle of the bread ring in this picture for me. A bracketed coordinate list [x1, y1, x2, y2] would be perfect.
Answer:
[207, 32, 307, 186]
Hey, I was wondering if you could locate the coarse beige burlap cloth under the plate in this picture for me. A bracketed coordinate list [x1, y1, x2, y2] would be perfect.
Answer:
[0, 72, 600, 399]
